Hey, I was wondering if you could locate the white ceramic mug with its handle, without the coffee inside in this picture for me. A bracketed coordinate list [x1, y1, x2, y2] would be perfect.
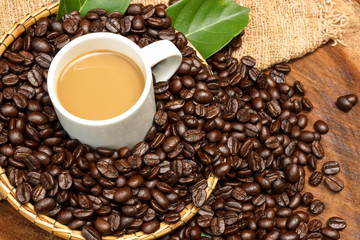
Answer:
[47, 33, 182, 149]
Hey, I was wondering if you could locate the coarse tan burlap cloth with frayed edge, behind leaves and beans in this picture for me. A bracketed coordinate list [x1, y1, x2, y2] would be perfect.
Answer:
[0, 0, 348, 70]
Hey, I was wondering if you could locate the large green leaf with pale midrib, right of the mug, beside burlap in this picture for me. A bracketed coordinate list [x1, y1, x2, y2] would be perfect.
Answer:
[166, 0, 250, 59]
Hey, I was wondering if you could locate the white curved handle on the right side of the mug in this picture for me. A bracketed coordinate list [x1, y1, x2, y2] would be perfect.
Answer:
[141, 40, 182, 82]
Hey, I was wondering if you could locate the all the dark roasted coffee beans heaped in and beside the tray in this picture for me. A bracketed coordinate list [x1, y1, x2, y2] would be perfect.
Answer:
[0, 1, 346, 240]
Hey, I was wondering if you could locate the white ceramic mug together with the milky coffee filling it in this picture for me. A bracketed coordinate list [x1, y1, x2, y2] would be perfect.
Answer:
[47, 33, 182, 148]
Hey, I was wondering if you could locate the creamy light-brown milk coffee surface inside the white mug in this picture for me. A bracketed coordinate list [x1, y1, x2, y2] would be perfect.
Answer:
[56, 50, 145, 120]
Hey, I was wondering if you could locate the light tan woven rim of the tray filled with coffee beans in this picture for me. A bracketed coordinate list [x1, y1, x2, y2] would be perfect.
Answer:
[0, 2, 218, 240]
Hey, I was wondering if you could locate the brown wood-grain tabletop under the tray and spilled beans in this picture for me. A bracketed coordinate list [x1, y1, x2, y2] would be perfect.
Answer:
[0, 1, 360, 240]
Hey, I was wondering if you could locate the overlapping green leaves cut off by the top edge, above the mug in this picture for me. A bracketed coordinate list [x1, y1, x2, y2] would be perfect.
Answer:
[56, 0, 131, 21]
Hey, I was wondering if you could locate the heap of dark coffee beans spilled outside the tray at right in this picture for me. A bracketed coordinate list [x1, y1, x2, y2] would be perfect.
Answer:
[155, 28, 346, 240]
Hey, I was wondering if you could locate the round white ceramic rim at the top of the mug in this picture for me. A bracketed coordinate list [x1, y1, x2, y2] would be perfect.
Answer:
[47, 33, 152, 126]
